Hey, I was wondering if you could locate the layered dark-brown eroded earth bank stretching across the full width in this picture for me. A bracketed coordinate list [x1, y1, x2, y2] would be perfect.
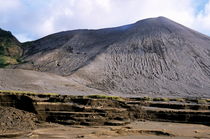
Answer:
[0, 92, 210, 126]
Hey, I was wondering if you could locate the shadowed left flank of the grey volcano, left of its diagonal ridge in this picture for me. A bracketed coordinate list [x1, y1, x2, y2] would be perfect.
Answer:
[18, 28, 124, 76]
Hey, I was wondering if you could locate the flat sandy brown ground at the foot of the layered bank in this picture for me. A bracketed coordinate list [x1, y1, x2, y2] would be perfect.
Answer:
[2, 121, 210, 139]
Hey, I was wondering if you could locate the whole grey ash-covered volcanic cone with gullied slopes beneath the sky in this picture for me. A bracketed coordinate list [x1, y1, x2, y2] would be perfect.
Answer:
[19, 17, 210, 97]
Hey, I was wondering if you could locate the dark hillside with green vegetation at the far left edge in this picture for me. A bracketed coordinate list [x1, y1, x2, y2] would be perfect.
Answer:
[0, 29, 22, 67]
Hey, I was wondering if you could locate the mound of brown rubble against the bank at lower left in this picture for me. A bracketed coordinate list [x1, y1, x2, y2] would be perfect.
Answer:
[0, 106, 38, 134]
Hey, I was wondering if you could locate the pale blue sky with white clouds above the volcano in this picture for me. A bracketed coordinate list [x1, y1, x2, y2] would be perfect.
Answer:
[0, 0, 210, 42]
